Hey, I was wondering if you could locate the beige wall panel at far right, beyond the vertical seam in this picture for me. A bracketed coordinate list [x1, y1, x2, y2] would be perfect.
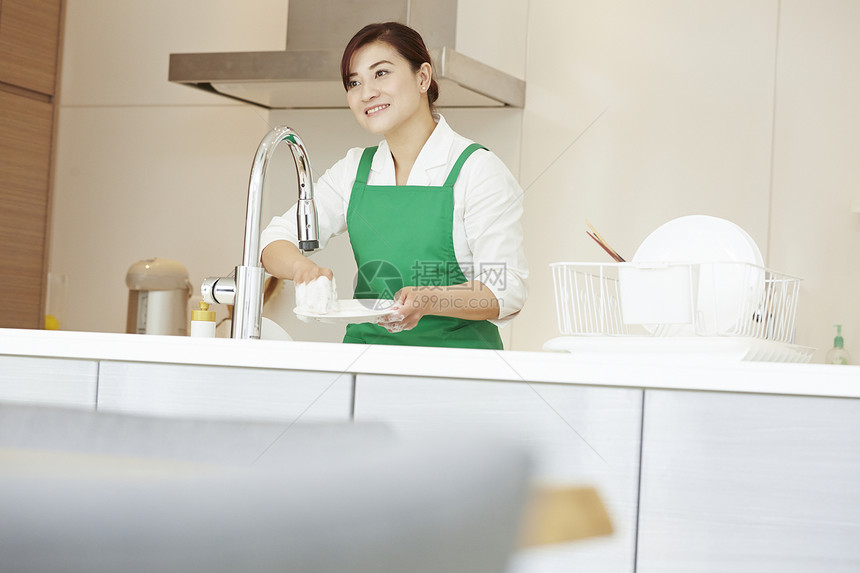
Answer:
[768, 0, 860, 364]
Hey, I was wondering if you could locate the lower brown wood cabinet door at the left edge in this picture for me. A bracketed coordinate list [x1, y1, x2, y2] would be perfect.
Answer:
[0, 91, 53, 328]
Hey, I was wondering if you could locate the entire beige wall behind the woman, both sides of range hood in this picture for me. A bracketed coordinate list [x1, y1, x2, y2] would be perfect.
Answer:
[50, 0, 860, 361]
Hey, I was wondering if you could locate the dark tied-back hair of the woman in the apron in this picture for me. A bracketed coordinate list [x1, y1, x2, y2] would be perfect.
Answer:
[340, 22, 439, 109]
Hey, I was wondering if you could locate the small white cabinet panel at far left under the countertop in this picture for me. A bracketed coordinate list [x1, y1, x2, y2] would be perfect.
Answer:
[0, 355, 98, 409]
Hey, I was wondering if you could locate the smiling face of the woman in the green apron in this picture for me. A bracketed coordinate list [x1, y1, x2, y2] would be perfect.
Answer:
[346, 42, 431, 134]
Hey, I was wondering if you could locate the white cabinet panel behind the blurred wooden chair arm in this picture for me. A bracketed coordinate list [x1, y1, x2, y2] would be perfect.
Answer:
[355, 375, 642, 573]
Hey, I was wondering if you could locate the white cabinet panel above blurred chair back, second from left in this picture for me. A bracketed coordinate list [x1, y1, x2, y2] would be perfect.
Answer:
[98, 361, 353, 421]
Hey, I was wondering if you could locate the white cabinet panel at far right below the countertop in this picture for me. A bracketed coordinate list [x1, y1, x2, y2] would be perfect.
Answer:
[636, 388, 860, 573]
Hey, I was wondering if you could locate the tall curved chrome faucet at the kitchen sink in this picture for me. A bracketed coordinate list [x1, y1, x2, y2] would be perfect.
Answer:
[200, 126, 319, 338]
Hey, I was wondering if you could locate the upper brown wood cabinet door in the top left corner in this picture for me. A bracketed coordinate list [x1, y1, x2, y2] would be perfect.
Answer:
[0, 0, 62, 95]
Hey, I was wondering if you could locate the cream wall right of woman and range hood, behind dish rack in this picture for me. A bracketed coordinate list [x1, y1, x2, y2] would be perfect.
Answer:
[513, 0, 860, 363]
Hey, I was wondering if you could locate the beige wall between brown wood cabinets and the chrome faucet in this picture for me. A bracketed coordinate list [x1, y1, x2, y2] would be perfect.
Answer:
[49, 0, 286, 332]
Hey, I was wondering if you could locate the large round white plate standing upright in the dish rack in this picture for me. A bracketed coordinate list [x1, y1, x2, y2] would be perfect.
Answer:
[633, 215, 764, 336]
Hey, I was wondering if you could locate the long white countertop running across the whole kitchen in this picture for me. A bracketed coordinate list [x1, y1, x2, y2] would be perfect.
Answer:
[0, 329, 860, 398]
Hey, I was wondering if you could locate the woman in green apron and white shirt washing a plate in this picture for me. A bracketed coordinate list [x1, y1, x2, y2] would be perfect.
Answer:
[261, 22, 528, 349]
